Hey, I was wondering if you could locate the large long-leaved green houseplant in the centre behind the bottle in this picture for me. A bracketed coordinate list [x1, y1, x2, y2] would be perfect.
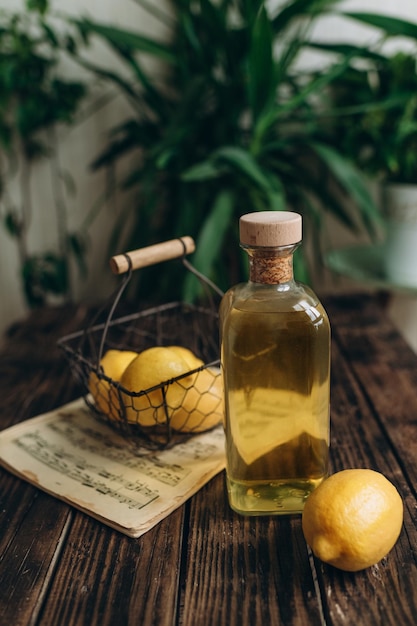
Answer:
[71, 0, 396, 299]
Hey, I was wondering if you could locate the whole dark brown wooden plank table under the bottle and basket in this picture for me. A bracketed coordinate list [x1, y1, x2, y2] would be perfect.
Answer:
[0, 296, 417, 626]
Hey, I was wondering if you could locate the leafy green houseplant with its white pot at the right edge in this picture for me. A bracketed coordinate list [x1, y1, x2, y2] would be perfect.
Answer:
[324, 15, 417, 287]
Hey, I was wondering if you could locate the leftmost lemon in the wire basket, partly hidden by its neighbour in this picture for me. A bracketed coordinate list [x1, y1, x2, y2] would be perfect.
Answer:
[88, 349, 137, 419]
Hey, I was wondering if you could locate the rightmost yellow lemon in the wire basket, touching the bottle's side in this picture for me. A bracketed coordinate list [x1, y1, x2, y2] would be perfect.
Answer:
[167, 367, 223, 432]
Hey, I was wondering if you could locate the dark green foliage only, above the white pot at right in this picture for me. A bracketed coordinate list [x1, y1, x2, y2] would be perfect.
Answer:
[326, 52, 417, 183]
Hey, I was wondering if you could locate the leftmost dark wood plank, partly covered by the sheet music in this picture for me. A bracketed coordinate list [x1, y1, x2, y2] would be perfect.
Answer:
[0, 309, 88, 626]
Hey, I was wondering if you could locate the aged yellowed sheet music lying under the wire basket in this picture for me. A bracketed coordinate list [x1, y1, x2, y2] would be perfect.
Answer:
[0, 398, 225, 537]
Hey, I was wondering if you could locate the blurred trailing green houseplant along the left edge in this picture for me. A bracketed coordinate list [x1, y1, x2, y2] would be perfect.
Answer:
[0, 0, 86, 306]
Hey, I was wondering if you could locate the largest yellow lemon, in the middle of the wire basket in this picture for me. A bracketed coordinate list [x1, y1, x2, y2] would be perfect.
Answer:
[121, 346, 190, 426]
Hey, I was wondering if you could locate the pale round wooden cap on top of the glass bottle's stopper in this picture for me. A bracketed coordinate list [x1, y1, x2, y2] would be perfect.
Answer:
[239, 211, 302, 248]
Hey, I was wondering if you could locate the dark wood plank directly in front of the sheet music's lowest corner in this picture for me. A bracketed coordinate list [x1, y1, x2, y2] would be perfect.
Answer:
[37, 509, 184, 626]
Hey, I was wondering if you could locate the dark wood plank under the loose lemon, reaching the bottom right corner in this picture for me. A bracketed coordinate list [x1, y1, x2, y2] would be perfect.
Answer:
[316, 330, 417, 626]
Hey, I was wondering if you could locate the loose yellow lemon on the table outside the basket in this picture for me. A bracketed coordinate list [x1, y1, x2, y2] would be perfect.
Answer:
[302, 469, 403, 572]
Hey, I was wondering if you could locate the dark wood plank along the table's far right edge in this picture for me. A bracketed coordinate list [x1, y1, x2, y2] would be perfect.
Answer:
[329, 298, 417, 486]
